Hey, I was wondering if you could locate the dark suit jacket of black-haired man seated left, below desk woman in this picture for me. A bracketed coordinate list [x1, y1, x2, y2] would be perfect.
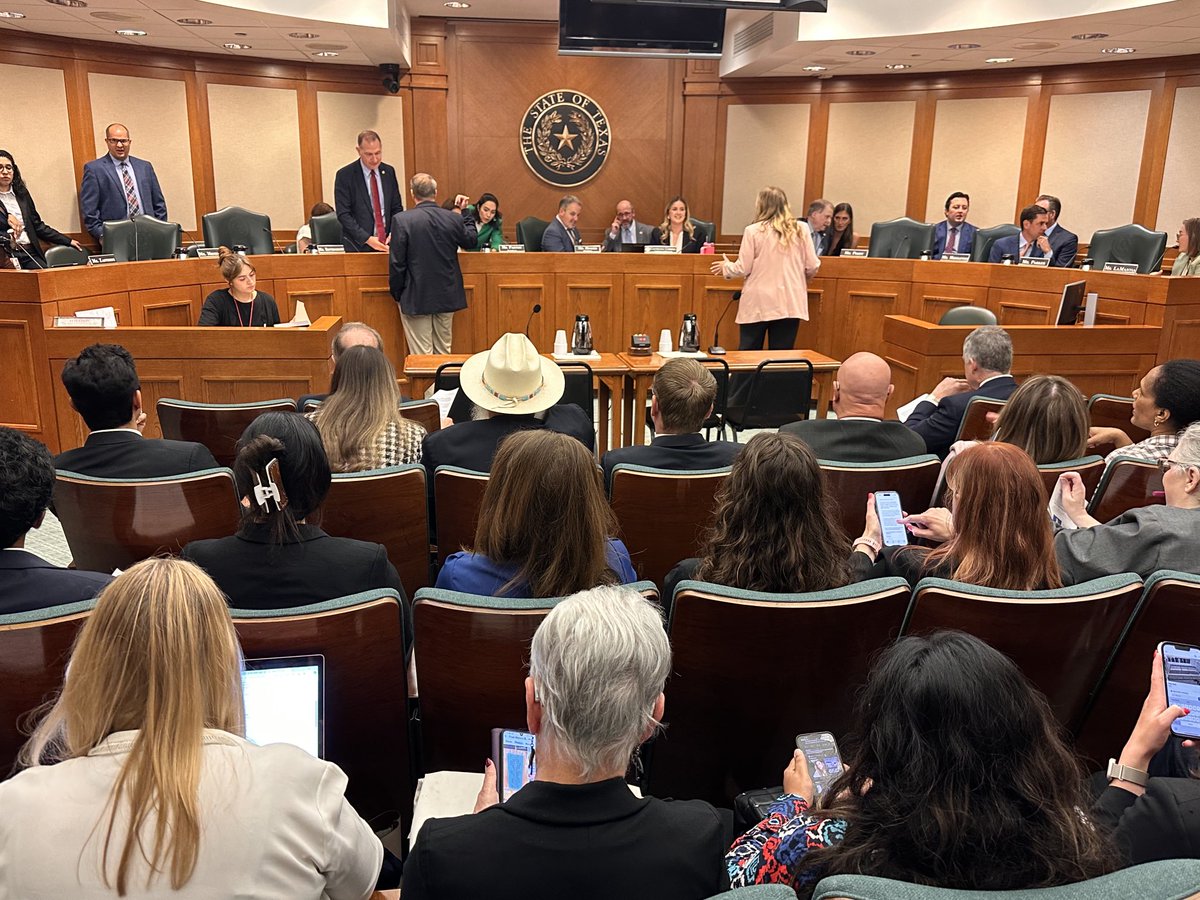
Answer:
[54, 431, 217, 478]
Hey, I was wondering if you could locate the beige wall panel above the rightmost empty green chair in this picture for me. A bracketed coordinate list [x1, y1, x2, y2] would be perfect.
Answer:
[1041, 91, 1150, 244]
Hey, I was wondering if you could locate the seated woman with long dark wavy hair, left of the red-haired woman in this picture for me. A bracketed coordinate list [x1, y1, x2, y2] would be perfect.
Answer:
[662, 432, 852, 604]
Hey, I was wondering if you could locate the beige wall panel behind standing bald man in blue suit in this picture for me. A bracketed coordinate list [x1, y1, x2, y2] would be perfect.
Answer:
[88, 73, 199, 232]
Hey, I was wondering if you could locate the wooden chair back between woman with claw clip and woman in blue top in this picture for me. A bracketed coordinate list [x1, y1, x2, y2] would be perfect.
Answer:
[320, 463, 432, 596]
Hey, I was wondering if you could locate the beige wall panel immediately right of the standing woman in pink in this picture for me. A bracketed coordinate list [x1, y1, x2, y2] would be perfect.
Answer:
[830, 100, 917, 239]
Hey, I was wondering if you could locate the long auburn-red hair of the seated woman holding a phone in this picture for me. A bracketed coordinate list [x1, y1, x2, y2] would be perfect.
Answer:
[925, 440, 1062, 590]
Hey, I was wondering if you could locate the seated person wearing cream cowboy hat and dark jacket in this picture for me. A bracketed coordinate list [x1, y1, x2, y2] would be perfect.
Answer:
[421, 334, 596, 485]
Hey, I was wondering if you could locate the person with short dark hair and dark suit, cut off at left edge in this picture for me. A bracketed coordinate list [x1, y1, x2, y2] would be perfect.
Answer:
[0, 428, 110, 614]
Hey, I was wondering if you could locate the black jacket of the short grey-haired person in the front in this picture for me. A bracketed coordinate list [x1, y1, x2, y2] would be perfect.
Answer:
[402, 779, 728, 900]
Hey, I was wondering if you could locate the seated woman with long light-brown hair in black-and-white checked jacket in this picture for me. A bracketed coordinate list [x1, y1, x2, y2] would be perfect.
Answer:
[308, 347, 425, 472]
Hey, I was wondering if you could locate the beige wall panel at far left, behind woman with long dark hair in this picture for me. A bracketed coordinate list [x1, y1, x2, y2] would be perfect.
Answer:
[0, 65, 80, 232]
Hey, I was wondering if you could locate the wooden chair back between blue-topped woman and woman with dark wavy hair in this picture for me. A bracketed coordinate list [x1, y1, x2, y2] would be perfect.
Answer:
[610, 463, 730, 584]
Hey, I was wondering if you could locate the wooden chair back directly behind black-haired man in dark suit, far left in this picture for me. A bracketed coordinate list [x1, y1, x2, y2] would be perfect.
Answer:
[54, 469, 241, 572]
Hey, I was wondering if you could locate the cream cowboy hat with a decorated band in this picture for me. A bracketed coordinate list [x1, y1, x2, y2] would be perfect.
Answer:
[460, 332, 564, 415]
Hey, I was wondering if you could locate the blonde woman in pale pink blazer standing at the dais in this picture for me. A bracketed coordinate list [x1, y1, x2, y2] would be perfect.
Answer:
[713, 187, 821, 350]
